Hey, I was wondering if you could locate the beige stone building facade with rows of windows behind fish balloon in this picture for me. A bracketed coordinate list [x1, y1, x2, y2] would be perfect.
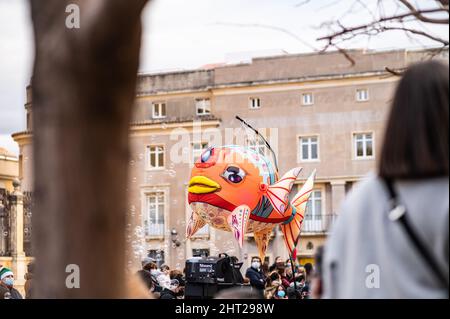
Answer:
[13, 50, 448, 268]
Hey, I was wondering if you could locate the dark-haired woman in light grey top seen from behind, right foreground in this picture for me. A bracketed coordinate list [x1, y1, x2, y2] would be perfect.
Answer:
[323, 61, 449, 299]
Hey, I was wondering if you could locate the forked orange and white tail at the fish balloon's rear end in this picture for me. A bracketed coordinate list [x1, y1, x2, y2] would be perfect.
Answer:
[281, 170, 316, 259]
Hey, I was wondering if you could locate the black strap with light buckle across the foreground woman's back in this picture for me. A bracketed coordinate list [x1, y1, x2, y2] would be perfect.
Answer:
[383, 178, 449, 290]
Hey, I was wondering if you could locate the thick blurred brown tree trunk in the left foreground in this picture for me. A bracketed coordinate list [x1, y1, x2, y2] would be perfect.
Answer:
[30, 0, 147, 298]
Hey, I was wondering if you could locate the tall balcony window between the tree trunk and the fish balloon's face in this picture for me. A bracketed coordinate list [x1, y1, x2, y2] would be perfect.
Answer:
[144, 192, 165, 237]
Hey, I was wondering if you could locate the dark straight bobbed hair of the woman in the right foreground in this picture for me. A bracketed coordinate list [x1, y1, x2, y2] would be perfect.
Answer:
[379, 61, 449, 179]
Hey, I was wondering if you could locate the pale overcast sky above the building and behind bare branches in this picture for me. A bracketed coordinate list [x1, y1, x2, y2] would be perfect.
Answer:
[0, 0, 448, 153]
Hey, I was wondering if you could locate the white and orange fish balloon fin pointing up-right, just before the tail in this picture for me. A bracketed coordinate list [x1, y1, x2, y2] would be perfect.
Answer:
[265, 167, 302, 216]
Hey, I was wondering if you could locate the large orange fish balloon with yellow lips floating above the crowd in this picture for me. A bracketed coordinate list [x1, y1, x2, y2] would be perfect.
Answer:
[186, 145, 315, 260]
